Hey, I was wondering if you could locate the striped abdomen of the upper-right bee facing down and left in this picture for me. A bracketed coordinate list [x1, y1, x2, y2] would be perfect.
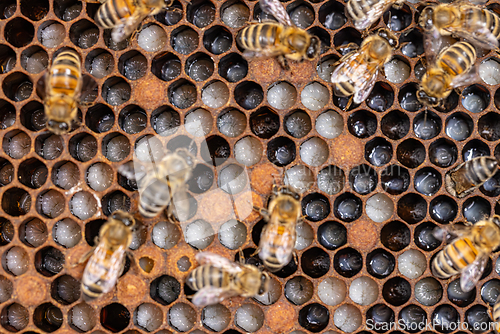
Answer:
[437, 42, 476, 77]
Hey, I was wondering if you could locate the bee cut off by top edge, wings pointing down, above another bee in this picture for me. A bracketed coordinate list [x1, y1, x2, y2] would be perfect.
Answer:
[345, 0, 404, 30]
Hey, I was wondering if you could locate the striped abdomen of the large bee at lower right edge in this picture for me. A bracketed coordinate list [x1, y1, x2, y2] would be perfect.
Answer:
[431, 238, 478, 279]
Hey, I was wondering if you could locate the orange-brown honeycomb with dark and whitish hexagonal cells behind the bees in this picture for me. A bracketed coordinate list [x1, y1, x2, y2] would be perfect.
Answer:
[0, 0, 500, 334]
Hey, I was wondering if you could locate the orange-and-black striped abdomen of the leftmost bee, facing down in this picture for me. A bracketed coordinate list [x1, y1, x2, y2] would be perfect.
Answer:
[47, 50, 82, 97]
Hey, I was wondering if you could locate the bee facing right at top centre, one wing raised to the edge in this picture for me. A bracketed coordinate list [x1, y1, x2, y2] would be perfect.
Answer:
[236, 0, 321, 70]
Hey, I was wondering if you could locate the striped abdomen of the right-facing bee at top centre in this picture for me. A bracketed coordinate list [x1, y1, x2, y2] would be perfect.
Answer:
[236, 23, 283, 51]
